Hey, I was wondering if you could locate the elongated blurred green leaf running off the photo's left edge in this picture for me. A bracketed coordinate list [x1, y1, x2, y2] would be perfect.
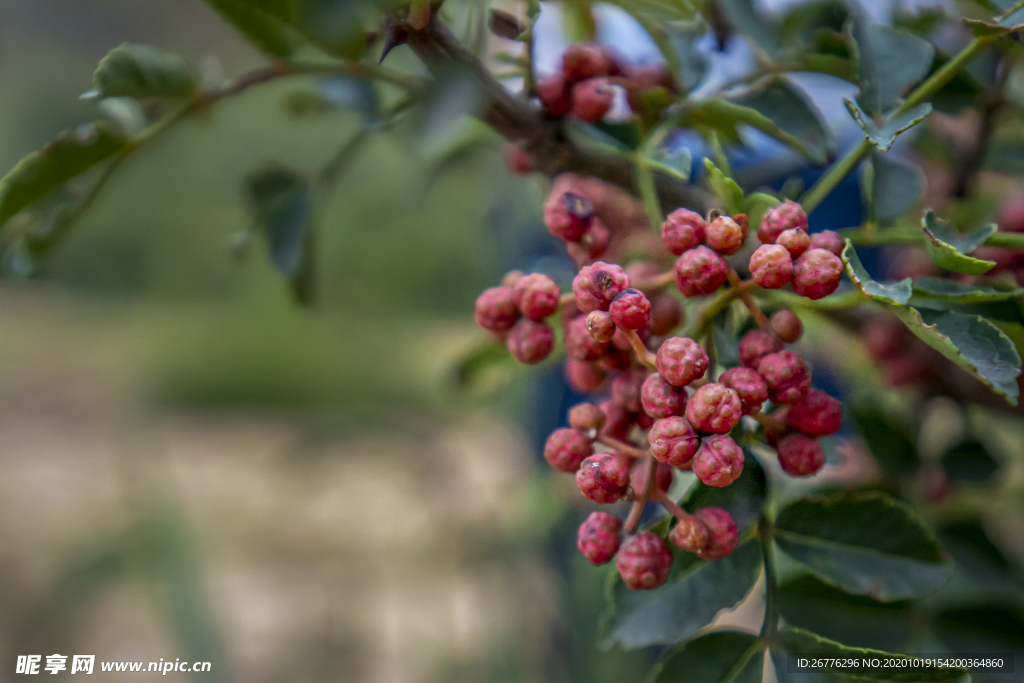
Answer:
[0, 121, 128, 225]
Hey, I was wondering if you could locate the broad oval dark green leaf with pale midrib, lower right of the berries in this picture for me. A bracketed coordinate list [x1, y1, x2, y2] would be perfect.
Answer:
[775, 493, 949, 600]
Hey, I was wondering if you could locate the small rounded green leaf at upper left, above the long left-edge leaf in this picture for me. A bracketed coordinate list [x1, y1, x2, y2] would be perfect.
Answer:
[92, 43, 199, 97]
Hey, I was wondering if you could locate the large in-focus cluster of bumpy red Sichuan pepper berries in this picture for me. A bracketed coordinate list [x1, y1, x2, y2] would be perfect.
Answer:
[476, 181, 842, 590]
